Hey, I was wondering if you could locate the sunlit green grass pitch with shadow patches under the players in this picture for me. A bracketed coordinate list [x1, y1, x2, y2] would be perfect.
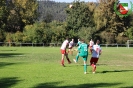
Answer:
[0, 47, 133, 88]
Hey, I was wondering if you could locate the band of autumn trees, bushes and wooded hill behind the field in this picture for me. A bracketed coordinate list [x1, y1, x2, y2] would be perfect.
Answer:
[0, 0, 133, 44]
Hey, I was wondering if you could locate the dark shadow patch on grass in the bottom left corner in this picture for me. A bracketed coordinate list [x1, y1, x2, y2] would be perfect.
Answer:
[0, 77, 21, 88]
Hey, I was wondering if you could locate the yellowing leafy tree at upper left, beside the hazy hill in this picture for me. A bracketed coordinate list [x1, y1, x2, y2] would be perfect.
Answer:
[6, 0, 37, 32]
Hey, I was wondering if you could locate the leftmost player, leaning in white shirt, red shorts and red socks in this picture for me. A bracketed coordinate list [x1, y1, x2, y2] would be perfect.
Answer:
[60, 38, 71, 66]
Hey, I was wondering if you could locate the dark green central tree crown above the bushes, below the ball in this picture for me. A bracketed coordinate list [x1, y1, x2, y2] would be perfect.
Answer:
[66, 1, 94, 31]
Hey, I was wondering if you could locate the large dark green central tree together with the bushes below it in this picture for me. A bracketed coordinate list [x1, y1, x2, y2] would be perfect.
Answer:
[66, 1, 95, 41]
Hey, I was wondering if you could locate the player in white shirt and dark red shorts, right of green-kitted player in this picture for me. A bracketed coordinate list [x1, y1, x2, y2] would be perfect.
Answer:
[90, 40, 102, 73]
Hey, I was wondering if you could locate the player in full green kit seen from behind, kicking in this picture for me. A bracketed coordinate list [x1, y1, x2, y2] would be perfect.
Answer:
[78, 40, 88, 74]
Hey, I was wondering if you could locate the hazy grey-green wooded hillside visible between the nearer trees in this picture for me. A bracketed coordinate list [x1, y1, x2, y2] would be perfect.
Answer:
[38, 0, 68, 23]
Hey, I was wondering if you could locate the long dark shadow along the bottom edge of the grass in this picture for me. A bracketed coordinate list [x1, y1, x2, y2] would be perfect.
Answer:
[33, 82, 122, 88]
